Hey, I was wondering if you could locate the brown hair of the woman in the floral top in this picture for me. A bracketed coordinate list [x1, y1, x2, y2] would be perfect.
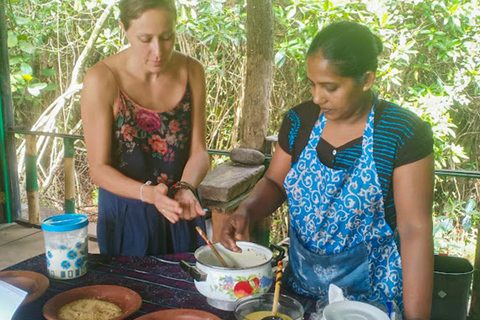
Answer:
[118, 0, 177, 30]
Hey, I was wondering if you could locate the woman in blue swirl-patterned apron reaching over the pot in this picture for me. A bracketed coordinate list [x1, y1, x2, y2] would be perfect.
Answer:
[221, 22, 433, 319]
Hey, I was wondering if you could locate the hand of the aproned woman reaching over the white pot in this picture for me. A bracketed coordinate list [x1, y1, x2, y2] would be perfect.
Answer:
[220, 207, 250, 252]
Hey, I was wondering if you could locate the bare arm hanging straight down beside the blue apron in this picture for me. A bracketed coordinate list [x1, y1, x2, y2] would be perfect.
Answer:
[393, 154, 434, 320]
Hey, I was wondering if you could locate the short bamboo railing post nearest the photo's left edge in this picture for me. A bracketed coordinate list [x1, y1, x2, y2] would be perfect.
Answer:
[25, 135, 40, 224]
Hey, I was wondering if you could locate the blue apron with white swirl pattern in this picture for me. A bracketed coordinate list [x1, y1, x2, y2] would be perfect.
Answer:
[284, 102, 403, 311]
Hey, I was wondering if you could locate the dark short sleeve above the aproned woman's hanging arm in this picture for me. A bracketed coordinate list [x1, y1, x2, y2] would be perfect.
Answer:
[394, 117, 433, 167]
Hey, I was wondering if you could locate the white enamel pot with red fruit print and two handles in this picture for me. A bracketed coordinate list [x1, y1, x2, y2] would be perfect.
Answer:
[181, 241, 285, 311]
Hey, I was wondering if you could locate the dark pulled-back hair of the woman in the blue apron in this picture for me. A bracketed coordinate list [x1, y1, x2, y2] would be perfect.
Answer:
[307, 21, 383, 78]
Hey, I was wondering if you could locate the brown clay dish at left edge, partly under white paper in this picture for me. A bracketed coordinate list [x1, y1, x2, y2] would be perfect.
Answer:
[0, 270, 50, 306]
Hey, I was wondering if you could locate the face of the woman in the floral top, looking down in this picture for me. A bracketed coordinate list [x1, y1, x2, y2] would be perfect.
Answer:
[126, 9, 175, 73]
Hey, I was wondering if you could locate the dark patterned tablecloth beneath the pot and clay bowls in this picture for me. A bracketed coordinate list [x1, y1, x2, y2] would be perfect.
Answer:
[5, 253, 315, 320]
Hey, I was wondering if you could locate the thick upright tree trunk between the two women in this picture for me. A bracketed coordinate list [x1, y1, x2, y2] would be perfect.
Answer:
[240, 0, 273, 152]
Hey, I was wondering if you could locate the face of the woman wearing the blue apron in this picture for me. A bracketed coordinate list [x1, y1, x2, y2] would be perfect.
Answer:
[307, 52, 370, 120]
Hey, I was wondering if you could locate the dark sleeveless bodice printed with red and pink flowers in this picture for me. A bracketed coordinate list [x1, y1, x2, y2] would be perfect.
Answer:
[112, 85, 192, 186]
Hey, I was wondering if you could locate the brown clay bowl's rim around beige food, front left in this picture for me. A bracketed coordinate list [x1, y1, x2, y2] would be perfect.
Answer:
[43, 285, 142, 320]
